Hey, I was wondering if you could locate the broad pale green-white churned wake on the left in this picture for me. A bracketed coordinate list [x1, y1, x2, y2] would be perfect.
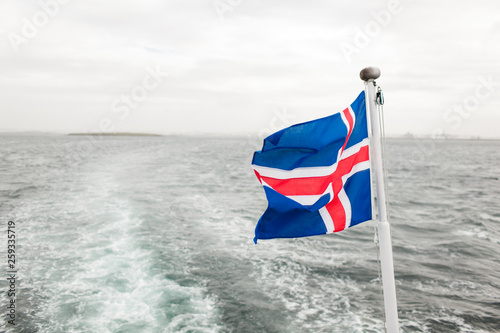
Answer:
[7, 167, 225, 332]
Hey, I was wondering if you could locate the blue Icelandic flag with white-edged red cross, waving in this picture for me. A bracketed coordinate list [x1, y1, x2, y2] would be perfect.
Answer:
[252, 91, 372, 243]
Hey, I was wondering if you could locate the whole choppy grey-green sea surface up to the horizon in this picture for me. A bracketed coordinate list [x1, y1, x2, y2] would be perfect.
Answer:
[0, 136, 500, 333]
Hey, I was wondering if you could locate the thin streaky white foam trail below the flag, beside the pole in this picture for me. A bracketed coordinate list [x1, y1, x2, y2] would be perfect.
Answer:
[178, 188, 383, 332]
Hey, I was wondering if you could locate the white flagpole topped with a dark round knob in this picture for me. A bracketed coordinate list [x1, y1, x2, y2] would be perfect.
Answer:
[359, 67, 399, 333]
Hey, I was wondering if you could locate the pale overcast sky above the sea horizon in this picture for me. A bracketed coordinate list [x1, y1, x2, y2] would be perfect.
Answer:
[0, 0, 500, 137]
